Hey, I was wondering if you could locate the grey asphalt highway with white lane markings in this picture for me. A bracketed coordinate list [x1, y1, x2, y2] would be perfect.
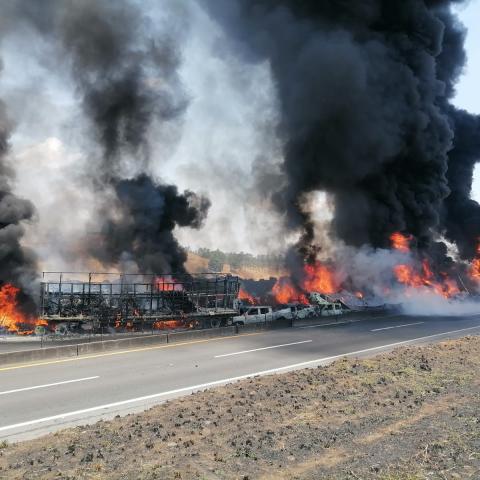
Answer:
[0, 314, 480, 442]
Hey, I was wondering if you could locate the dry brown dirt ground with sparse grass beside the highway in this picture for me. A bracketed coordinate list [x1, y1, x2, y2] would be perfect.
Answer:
[0, 337, 480, 480]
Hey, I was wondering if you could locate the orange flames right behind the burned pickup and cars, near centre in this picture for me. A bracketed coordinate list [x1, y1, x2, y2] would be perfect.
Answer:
[272, 262, 340, 303]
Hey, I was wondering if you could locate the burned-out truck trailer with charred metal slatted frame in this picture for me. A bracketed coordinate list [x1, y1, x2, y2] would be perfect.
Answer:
[41, 272, 240, 330]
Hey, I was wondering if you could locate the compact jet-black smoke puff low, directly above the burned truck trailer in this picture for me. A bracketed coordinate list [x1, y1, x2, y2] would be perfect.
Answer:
[92, 175, 210, 272]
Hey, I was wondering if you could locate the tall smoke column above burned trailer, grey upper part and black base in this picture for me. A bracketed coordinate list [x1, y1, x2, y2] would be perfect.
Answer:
[17, 0, 209, 273]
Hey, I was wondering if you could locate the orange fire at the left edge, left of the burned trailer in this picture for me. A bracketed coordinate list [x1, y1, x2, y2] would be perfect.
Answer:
[0, 283, 47, 335]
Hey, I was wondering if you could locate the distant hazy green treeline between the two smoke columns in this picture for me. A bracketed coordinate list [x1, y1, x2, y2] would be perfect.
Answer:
[193, 248, 284, 272]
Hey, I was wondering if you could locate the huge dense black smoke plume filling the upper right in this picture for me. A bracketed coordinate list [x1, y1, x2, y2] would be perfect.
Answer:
[204, 0, 480, 266]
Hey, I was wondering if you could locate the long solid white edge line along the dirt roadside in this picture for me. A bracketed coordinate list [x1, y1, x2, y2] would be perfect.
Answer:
[0, 325, 480, 432]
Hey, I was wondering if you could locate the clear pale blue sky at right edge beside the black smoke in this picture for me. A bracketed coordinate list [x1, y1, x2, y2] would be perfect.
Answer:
[454, 0, 480, 202]
